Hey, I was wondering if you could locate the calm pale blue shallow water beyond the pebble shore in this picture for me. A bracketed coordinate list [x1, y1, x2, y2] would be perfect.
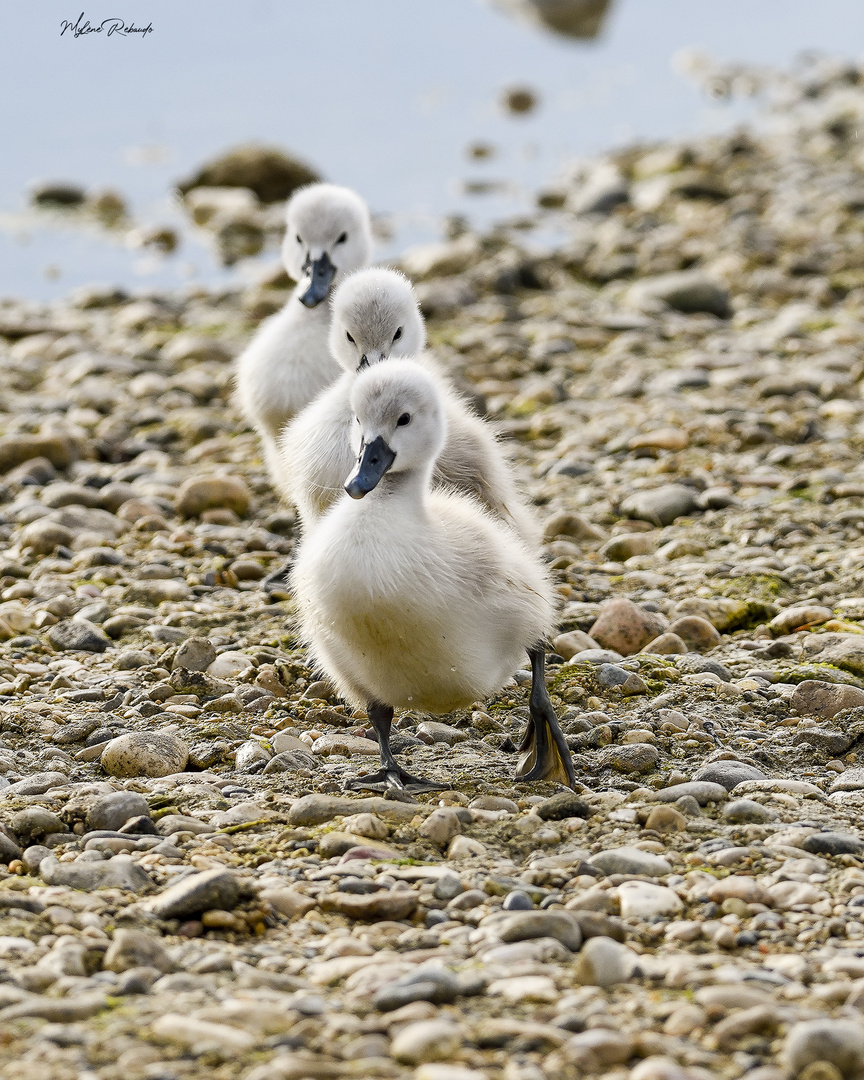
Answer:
[0, 0, 864, 299]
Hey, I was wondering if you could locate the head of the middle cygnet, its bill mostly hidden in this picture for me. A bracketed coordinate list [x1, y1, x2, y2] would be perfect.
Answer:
[329, 267, 426, 372]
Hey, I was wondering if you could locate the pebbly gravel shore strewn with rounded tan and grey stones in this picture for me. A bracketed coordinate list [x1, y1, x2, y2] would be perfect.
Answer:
[0, 54, 864, 1080]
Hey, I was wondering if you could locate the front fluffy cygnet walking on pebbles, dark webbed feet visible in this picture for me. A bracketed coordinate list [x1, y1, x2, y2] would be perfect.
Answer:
[293, 361, 573, 791]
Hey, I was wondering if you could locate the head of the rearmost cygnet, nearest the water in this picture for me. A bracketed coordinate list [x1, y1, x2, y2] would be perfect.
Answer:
[282, 184, 372, 308]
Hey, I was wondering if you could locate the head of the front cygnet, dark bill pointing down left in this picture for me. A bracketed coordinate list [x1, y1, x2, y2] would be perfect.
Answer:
[345, 360, 447, 499]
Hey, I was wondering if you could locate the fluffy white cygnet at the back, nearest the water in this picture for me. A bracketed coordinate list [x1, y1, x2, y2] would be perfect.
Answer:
[235, 184, 372, 474]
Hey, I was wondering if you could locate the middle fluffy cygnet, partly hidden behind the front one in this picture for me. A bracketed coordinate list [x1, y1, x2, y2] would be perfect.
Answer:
[276, 268, 538, 543]
